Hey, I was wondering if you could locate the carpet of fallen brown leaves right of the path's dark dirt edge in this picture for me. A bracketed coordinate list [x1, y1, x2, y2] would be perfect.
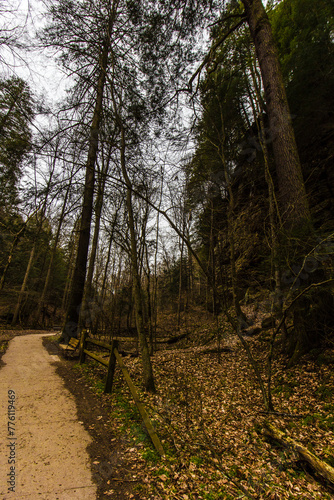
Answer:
[71, 312, 334, 500]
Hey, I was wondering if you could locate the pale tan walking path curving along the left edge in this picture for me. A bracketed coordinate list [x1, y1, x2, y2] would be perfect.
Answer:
[0, 334, 97, 500]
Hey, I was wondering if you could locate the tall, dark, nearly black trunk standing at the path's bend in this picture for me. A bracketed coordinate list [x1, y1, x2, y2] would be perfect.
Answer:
[63, 34, 111, 342]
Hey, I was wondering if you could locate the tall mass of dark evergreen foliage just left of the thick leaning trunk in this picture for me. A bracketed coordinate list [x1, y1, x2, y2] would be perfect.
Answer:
[186, 8, 270, 296]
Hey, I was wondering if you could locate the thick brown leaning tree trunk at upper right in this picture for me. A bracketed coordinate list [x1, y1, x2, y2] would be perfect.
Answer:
[242, 0, 311, 232]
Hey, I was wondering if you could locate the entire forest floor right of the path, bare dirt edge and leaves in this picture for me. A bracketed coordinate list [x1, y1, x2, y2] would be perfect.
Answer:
[0, 306, 334, 500]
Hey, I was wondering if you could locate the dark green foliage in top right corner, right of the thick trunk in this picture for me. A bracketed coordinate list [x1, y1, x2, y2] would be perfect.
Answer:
[271, 0, 334, 232]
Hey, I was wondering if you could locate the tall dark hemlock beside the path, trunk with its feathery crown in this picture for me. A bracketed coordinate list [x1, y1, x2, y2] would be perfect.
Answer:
[41, 0, 214, 387]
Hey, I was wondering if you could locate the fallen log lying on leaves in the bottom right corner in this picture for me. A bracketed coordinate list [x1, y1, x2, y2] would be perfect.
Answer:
[265, 422, 334, 484]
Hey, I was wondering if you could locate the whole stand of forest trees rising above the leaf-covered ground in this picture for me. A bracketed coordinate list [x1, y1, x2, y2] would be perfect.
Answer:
[0, 0, 334, 368]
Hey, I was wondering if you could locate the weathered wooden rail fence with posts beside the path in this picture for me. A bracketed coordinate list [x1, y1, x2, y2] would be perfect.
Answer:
[80, 330, 165, 456]
